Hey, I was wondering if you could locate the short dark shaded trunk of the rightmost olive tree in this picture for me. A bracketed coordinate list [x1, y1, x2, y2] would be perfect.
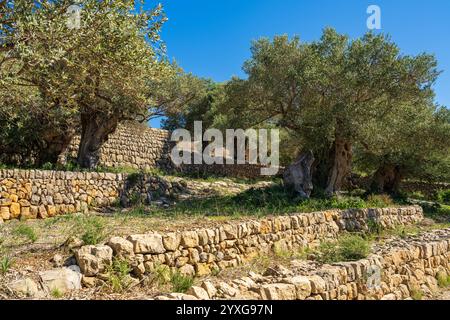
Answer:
[370, 164, 403, 194]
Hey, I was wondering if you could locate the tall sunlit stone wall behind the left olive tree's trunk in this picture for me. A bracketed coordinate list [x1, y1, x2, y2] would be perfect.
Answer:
[64, 122, 171, 169]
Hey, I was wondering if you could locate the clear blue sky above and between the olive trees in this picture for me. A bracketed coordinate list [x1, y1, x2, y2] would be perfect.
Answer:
[146, 0, 450, 127]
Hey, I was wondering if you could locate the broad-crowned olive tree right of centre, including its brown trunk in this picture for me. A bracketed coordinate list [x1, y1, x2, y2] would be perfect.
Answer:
[224, 29, 439, 195]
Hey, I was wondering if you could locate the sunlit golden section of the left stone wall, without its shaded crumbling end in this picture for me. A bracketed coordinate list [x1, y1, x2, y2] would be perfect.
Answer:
[0, 170, 125, 220]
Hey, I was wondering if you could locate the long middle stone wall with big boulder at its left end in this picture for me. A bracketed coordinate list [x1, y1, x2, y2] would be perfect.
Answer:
[76, 206, 423, 276]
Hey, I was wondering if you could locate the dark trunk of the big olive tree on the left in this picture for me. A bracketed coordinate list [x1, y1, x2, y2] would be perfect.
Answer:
[77, 113, 119, 169]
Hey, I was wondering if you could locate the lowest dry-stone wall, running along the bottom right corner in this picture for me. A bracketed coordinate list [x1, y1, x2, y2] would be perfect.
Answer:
[163, 229, 450, 300]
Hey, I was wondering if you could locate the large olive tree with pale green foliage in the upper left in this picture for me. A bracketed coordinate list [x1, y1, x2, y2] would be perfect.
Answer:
[0, 0, 172, 168]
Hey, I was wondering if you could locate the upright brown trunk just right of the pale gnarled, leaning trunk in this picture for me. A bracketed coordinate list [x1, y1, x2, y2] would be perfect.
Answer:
[325, 137, 353, 197]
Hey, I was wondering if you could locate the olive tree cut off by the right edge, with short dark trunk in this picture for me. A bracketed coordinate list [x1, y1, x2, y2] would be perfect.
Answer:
[356, 103, 450, 194]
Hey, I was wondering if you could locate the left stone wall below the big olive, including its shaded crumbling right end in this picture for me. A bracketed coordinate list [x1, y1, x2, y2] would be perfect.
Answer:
[0, 170, 184, 220]
